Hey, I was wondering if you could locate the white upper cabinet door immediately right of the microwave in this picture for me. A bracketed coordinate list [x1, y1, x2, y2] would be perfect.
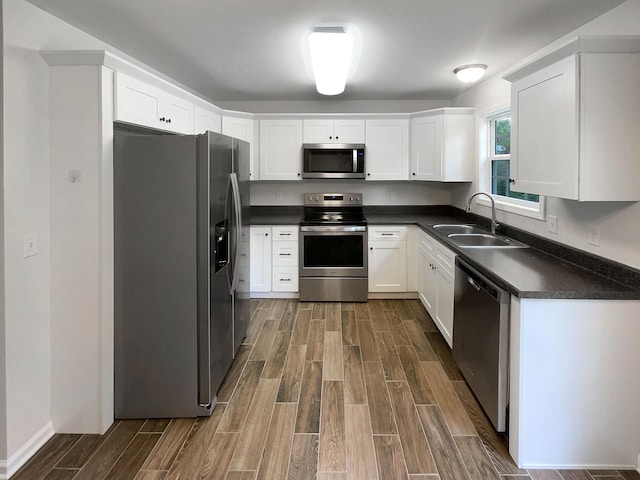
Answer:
[365, 119, 409, 180]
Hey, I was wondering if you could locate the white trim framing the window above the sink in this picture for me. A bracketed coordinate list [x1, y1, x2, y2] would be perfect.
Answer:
[475, 104, 546, 221]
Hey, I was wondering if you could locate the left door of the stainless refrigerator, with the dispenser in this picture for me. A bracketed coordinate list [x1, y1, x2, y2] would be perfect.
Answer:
[197, 132, 233, 409]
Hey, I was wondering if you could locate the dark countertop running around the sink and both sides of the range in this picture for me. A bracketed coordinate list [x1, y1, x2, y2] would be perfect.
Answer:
[251, 206, 640, 300]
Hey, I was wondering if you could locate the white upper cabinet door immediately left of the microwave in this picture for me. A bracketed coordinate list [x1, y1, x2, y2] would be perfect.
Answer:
[260, 119, 302, 180]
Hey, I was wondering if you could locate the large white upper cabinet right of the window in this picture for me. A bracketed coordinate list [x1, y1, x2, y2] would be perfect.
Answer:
[504, 37, 640, 201]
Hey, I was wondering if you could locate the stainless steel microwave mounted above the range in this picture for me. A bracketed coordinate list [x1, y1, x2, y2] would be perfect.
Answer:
[302, 143, 365, 178]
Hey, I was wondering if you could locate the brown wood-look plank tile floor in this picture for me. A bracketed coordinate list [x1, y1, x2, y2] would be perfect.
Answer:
[13, 299, 640, 480]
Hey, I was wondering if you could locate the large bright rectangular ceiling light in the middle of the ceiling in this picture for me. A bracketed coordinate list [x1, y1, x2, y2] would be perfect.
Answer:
[309, 27, 353, 95]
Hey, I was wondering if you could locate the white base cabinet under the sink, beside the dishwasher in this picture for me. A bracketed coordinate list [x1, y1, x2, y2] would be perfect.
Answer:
[418, 233, 456, 347]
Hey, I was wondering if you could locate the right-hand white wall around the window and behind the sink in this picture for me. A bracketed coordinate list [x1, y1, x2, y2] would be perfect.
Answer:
[452, 0, 640, 268]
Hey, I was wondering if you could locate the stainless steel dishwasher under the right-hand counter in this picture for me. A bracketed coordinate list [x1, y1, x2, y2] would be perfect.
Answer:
[453, 258, 510, 432]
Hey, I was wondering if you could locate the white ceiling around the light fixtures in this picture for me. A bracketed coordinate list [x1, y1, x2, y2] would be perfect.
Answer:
[28, 0, 622, 102]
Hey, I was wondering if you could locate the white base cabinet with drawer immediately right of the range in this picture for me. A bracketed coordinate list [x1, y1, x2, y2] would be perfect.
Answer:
[369, 226, 407, 292]
